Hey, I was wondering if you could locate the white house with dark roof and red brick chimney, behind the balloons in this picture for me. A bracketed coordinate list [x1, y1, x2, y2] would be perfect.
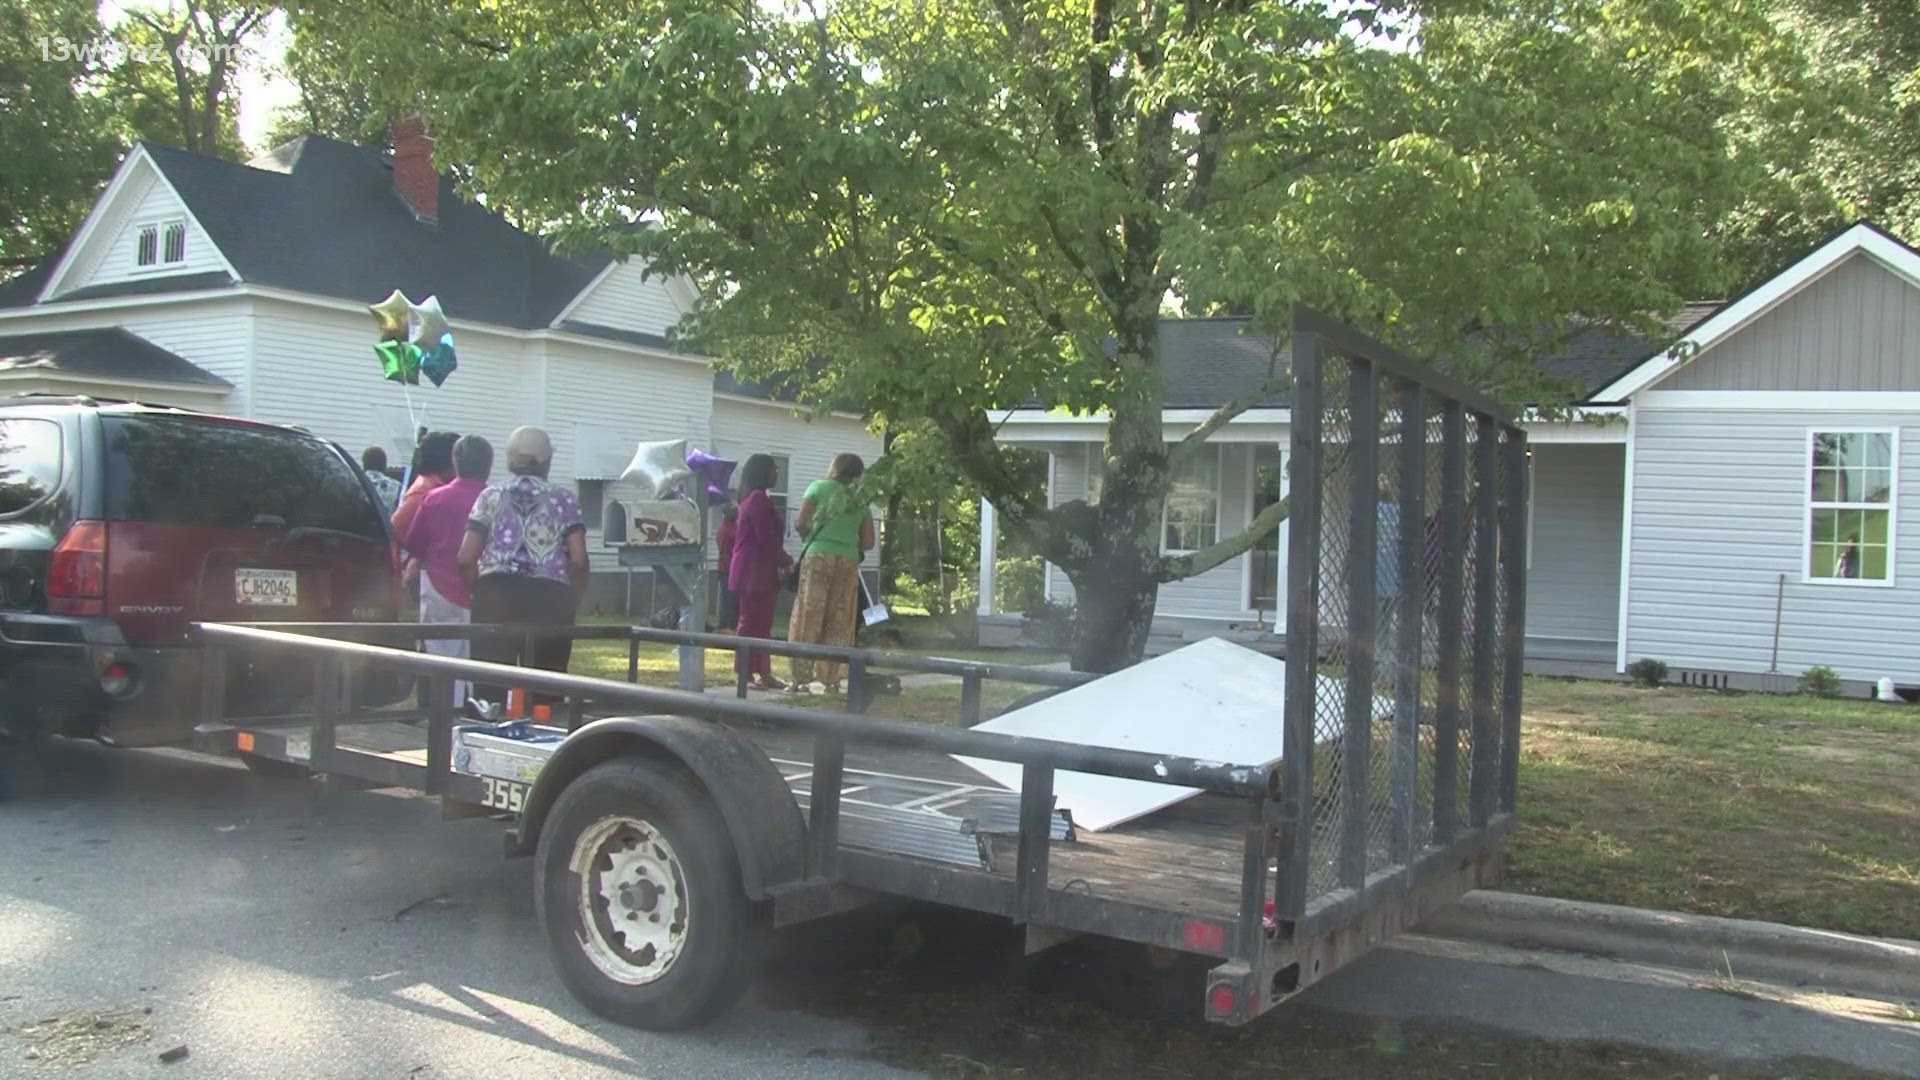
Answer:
[0, 125, 879, 603]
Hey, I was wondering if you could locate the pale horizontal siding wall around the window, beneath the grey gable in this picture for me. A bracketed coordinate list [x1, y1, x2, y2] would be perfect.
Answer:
[1620, 409, 1920, 682]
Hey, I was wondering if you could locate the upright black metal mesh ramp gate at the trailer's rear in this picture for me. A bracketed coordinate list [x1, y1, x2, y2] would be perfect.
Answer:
[1277, 311, 1526, 919]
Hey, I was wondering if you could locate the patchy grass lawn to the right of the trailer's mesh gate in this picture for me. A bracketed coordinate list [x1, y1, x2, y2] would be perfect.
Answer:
[1507, 678, 1920, 936]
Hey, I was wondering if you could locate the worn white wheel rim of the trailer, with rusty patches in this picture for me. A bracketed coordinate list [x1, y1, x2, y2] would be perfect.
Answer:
[568, 817, 689, 986]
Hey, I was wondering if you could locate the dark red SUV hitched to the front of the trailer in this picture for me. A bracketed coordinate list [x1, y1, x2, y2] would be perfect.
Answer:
[0, 396, 399, 746]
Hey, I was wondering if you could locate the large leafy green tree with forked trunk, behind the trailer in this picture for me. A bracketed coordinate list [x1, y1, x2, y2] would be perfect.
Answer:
[301, 0, 1766, 667]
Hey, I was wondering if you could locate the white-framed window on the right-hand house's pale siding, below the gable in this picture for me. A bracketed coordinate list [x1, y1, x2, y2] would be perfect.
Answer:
[1807, 430, 1897, 584]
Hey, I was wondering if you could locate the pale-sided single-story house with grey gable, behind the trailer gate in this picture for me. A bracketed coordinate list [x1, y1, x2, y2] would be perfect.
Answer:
[981, 223, 1920, 686]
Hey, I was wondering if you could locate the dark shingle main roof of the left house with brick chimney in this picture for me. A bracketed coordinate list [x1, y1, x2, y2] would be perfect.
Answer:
[41, 135, 607, 329]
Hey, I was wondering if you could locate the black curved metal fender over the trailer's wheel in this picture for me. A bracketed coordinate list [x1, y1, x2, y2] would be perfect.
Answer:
[507, 717, 806, 899]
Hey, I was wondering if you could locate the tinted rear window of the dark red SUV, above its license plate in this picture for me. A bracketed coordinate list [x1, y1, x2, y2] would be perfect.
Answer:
[102, 417, 386, 540]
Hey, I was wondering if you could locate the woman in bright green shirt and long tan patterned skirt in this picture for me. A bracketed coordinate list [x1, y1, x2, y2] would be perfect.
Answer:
[787, 454, 874, 694]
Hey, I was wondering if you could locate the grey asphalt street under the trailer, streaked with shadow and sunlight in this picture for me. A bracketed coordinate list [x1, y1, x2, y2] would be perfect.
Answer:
[0, 744, 1920, 1080]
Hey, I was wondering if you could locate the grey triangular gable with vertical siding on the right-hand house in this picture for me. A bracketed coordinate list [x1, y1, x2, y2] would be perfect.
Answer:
[1651, 252, 1920, 392]
